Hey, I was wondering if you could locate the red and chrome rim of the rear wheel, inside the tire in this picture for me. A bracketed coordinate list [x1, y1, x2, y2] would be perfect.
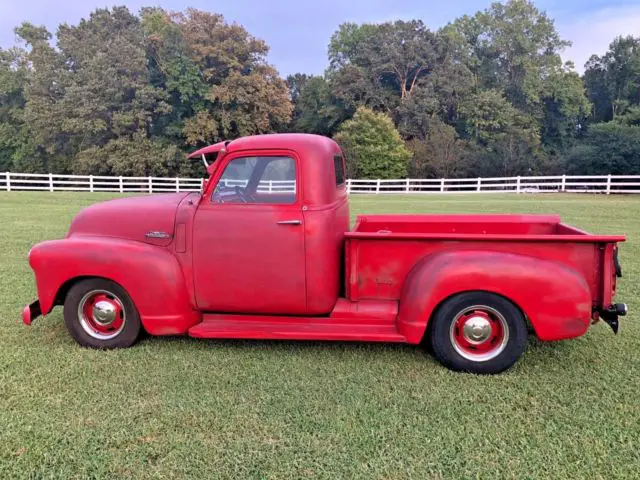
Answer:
[449, 305, 509, 362]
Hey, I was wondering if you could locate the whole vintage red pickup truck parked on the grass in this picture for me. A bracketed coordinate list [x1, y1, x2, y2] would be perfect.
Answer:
[23, 134, 626, 373]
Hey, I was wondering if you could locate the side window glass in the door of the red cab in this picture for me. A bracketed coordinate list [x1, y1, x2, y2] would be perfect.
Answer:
[211, 157, 297, 204]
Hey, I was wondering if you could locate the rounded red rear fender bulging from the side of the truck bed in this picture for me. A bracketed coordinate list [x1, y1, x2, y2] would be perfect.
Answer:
[398, 251, 592, 343]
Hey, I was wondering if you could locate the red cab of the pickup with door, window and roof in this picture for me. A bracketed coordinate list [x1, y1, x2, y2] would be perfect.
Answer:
[190, 135, 349, 315]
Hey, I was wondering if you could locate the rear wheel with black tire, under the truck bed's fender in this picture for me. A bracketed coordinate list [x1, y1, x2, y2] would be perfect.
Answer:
[428, 292, 527, 374]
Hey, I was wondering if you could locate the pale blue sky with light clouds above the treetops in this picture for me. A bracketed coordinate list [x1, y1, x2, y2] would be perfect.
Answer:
[0, 0, 640, 76]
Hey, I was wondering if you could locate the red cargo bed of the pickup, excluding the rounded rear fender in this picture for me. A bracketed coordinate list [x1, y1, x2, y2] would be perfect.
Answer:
[345, 215, 625, 304]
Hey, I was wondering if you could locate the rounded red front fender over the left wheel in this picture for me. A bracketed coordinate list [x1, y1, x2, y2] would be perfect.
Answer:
[29, 236, 200, 335]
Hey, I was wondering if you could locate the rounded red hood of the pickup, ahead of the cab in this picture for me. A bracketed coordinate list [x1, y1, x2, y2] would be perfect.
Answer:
[67, 192, 190, 246]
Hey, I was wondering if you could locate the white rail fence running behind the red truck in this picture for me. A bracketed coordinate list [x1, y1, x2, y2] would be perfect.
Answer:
[0, 172, 640, 195]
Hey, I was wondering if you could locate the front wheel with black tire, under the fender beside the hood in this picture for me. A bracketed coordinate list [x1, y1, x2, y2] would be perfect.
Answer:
[64, 278, 142, 349]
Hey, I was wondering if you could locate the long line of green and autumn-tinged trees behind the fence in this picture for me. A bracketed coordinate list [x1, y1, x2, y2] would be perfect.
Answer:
[0, 0, 640, 178]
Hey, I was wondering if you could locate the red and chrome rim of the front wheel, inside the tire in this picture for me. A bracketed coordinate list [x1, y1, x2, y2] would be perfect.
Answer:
[78, 290, 126, 340]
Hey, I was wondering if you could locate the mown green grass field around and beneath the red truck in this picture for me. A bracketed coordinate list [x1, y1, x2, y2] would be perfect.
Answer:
[0, 193, 640, 479]
